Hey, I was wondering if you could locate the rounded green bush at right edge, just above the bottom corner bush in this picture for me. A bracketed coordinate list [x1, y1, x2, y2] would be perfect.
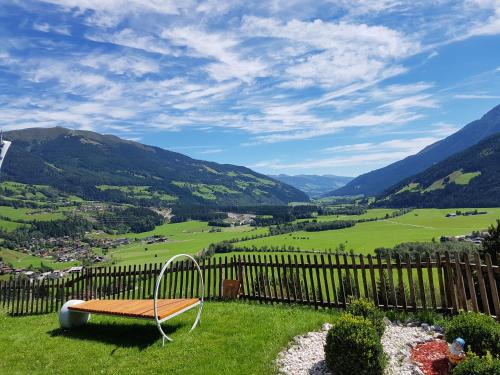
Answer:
[445, 312, 500, 356]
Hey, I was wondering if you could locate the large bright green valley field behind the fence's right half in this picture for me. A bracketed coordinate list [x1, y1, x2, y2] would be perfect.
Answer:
[238, 208, 500, 254]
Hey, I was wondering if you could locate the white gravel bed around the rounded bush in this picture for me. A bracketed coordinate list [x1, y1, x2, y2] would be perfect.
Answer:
[276, 323, 439, 375]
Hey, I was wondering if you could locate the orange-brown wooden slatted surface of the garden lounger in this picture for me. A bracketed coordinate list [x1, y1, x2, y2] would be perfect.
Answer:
[68, 298, 200, 319]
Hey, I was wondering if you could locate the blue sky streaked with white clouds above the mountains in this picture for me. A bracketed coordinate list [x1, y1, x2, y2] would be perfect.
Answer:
[0, 0, 500, 176]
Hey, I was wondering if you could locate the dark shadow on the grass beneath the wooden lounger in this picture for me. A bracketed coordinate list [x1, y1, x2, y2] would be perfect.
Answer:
[47, 322, 185, 350]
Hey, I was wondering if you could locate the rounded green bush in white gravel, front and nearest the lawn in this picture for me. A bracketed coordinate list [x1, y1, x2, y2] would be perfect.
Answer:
[325, 314, 387, 375]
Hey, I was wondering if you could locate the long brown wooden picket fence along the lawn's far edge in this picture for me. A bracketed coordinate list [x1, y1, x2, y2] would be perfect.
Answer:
[0, 254, 500, 319]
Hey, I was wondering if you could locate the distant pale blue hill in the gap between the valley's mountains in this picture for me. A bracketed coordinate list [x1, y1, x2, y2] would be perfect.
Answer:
[269, 174, 354, 198]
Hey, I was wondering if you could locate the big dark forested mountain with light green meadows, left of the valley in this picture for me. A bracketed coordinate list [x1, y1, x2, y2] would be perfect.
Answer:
[2, 127, 308, 205]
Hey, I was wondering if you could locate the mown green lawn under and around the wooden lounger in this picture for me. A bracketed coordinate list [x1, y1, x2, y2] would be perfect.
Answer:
[0, 302, 335, 374]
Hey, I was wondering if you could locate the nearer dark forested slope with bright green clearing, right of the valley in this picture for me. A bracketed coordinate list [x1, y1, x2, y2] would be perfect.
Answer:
[377, 134, 500, 207]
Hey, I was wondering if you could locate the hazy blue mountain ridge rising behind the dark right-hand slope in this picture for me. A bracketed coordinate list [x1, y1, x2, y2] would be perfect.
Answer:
[327, 105, 500, 196]
